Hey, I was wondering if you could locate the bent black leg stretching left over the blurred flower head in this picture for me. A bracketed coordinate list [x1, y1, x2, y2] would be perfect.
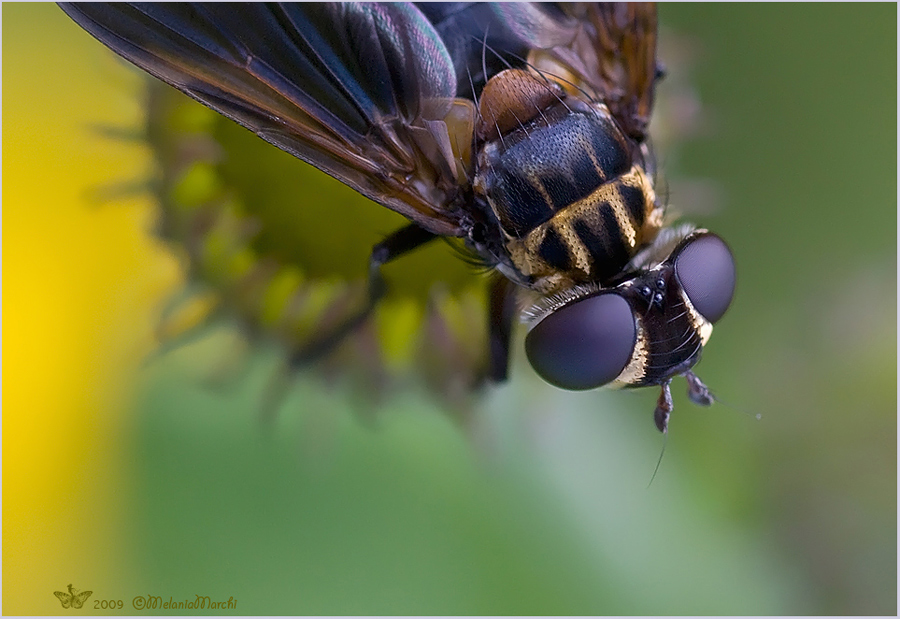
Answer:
[290, 224, 437, 366]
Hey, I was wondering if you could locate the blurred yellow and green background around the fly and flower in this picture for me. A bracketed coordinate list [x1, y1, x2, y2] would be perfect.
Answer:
[3, 4, 897, 614]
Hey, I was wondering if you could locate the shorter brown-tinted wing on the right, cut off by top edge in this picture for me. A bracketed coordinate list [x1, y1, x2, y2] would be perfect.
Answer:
[498, 2, 661, 142]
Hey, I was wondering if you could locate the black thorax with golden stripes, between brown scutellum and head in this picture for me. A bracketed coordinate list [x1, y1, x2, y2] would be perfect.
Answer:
[476, 98, 662, 292]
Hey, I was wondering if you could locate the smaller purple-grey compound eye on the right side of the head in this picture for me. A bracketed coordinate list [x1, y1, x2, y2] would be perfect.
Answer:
[675, 234, 736, 322]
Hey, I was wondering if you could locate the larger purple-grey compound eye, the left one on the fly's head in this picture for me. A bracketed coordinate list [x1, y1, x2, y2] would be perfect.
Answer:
[525, 293, 637, 390]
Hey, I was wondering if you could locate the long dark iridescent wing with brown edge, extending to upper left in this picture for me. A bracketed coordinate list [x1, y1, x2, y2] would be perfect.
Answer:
[61, 3, 474, 236]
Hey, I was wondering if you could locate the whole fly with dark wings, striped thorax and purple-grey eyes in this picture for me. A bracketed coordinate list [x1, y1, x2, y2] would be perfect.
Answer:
[62, 3, 735, 432]
